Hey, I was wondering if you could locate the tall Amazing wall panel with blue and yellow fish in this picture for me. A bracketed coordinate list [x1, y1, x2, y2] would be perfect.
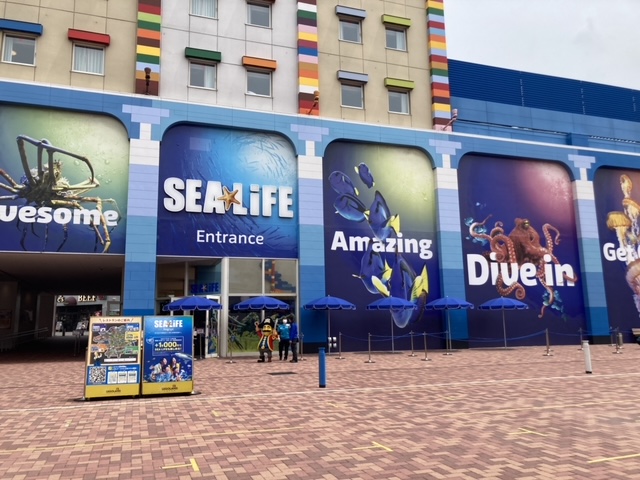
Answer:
[323, 142, 440, 349]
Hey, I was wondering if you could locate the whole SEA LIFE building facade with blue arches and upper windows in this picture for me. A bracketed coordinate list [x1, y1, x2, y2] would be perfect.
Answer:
[0, 0, 640, 355]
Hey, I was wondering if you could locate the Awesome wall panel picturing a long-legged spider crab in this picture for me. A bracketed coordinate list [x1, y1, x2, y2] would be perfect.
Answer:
[0, 105, 129, 254]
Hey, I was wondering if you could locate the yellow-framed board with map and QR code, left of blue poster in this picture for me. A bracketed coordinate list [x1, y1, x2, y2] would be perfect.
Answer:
[84, 317, 142, 399]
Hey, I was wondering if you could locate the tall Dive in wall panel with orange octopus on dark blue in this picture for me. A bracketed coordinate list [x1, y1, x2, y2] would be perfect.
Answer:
[458, 154, 586, 346]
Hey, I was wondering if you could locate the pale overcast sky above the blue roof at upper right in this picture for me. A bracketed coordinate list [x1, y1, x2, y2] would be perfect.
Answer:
[444, 0, 640, 90]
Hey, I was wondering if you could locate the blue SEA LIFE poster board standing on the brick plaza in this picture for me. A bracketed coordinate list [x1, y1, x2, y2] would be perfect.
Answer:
[142, 315, 193, 395]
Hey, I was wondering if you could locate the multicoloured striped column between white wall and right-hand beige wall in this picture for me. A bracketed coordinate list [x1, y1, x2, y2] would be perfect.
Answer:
[298, 0, 320, 115]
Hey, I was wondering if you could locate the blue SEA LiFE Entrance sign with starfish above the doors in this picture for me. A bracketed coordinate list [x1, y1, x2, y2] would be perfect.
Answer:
[158, 125, 298, 258]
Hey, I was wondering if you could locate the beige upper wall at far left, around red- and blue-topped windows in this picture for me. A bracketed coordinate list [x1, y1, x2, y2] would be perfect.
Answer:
[0, 0, 138, 93]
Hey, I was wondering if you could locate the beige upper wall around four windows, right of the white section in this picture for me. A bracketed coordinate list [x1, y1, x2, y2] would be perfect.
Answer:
[318, 0, 432, 128]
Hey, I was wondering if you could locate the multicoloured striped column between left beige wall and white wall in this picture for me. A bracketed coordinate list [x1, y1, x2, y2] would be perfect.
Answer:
[136, 0, 162, 95]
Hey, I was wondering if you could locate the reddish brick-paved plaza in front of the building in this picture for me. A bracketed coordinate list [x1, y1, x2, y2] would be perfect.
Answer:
[0, 339, 640, 480]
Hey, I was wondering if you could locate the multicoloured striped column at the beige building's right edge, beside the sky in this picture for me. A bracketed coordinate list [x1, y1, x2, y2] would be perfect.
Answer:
[427, 0, 451, 130]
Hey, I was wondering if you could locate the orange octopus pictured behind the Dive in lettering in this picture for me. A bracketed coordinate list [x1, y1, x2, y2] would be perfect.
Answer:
[469, 215, 577, 318]
